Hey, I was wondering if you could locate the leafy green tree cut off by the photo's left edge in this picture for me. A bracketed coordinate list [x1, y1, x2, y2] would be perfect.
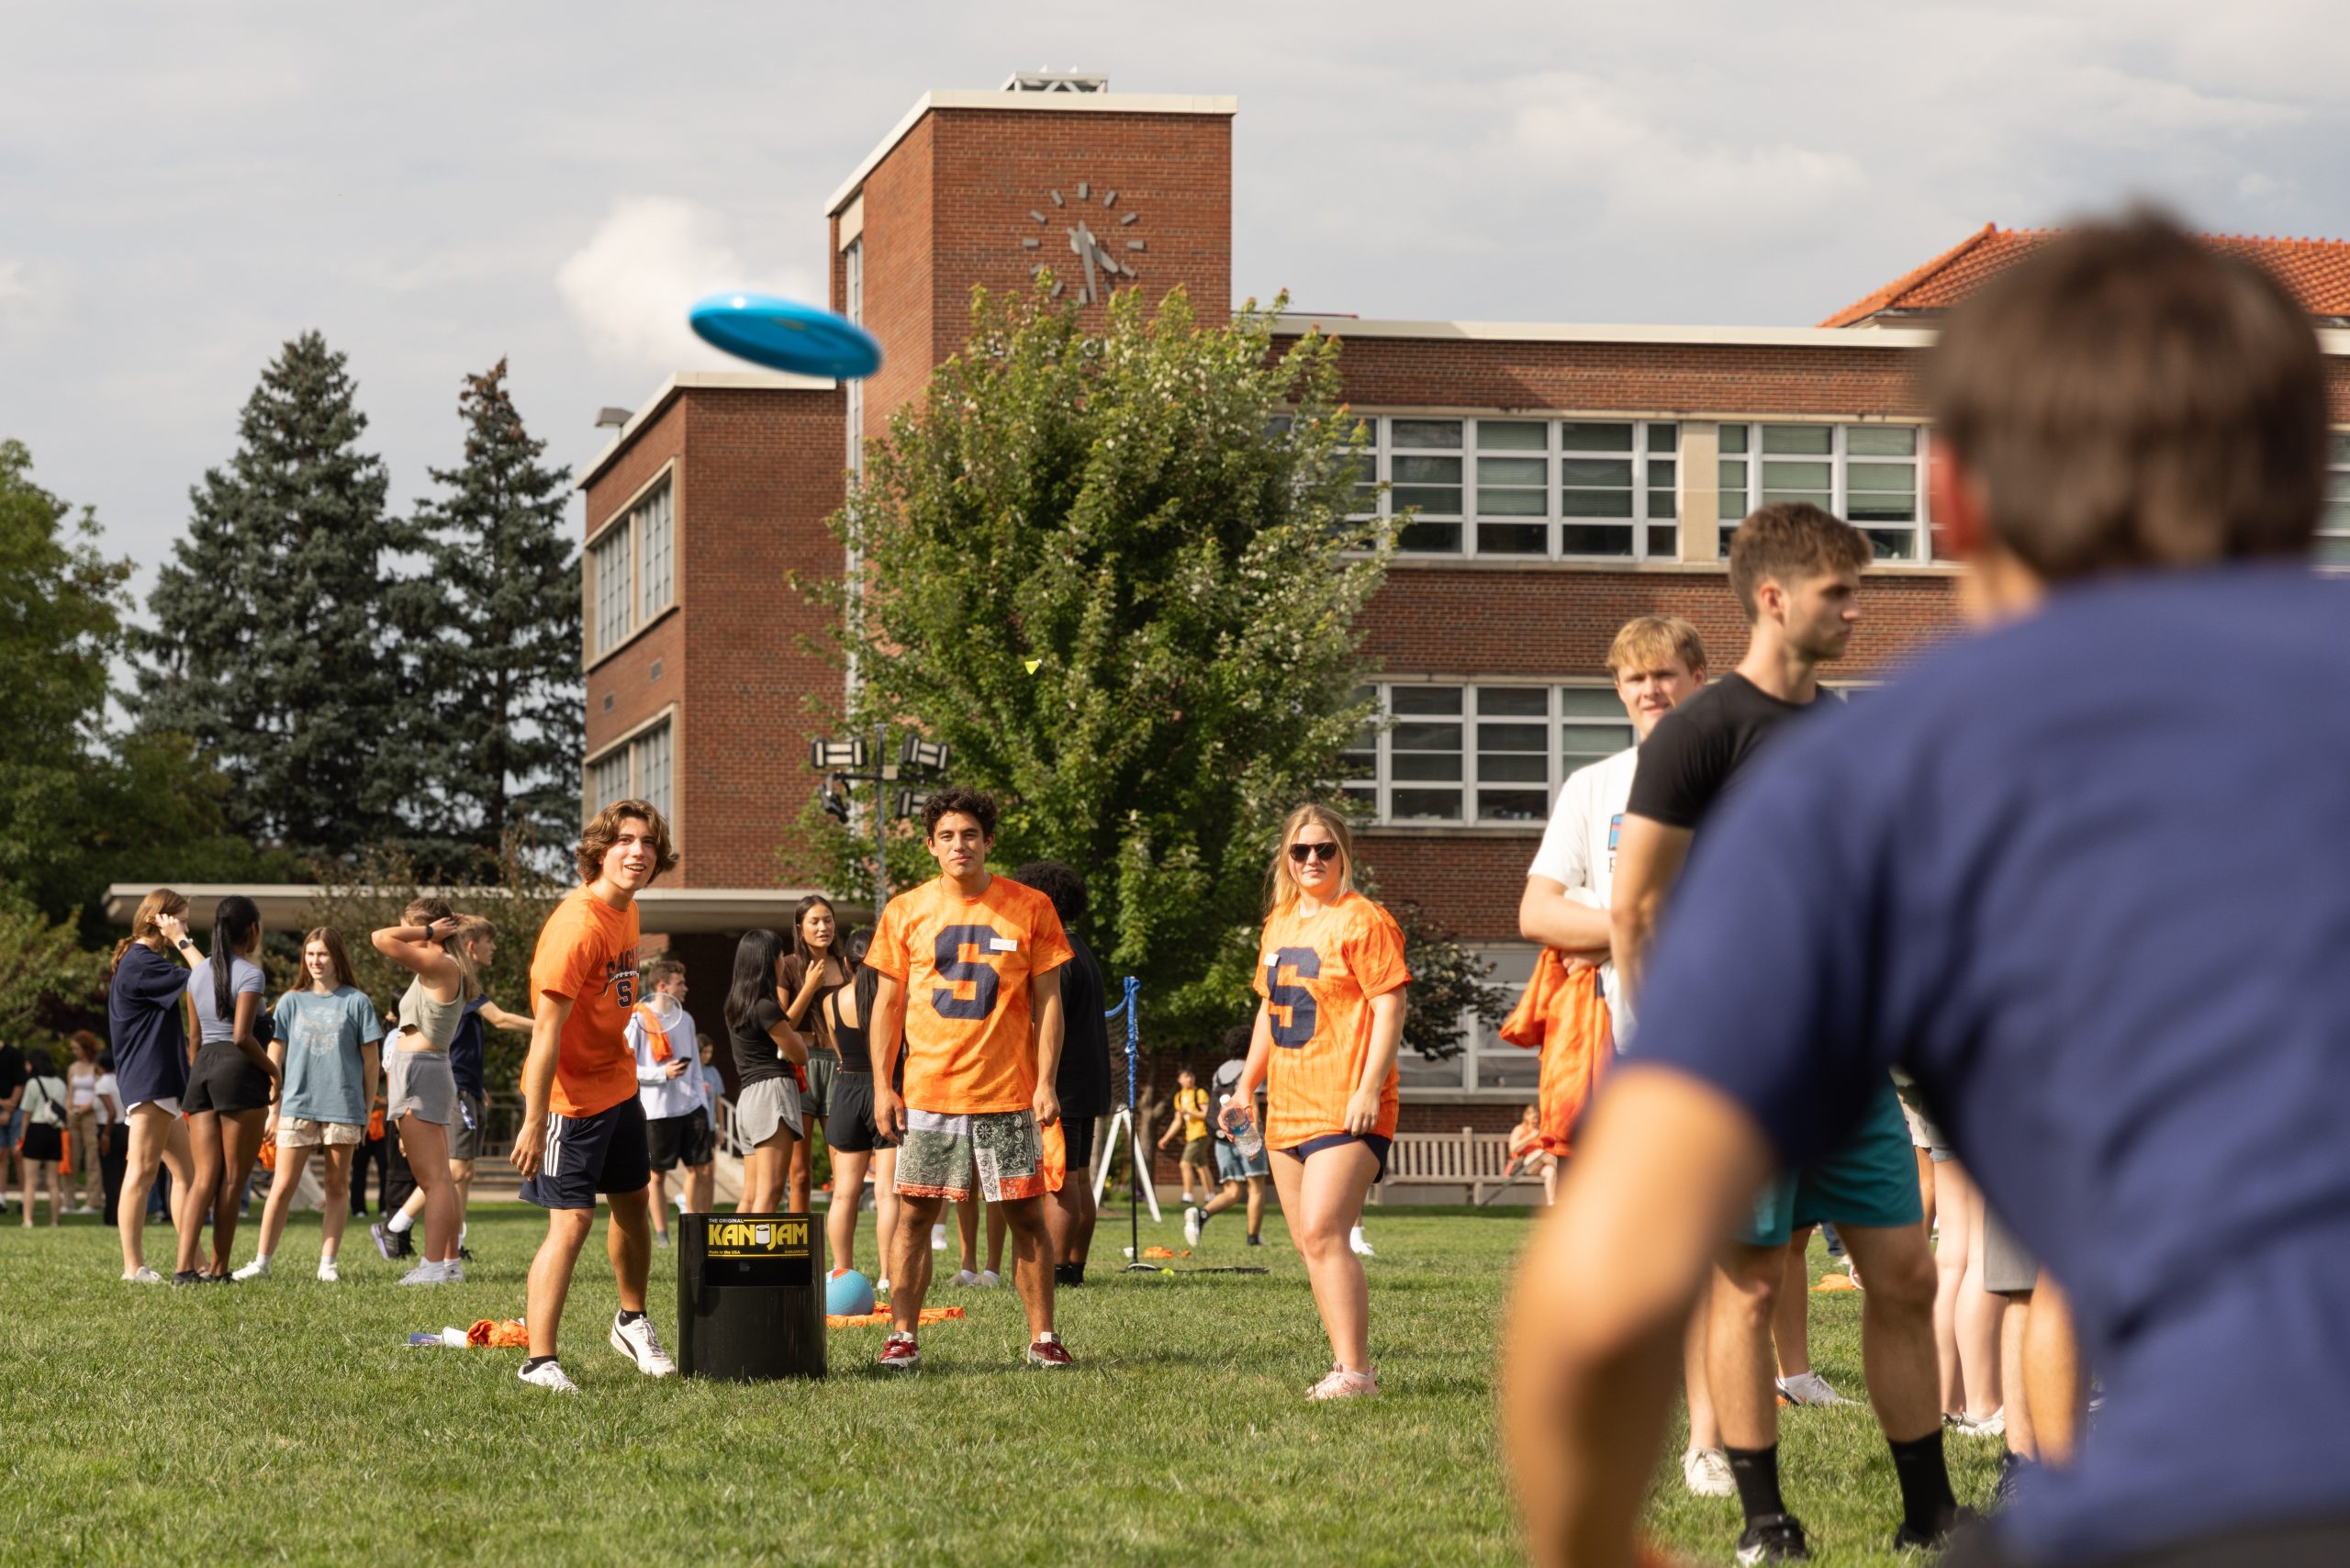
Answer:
[0, 442, 131, 893]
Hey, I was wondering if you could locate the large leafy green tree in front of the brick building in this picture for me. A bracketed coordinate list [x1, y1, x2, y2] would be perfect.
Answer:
[813, 280, 1389, 1039]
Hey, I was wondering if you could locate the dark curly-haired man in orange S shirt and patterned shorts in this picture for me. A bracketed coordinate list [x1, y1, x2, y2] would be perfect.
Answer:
[865, 790, 1074, 1371]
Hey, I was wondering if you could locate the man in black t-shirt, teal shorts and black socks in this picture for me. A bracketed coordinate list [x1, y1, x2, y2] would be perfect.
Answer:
[1612, 503, 1957, 1561]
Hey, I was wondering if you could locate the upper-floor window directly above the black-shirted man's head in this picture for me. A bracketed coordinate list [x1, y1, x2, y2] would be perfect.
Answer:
[1716, 423, 1931, 562]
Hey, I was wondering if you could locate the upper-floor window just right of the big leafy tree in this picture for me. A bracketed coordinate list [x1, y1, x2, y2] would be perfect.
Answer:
[1363, 414, 1680, 559]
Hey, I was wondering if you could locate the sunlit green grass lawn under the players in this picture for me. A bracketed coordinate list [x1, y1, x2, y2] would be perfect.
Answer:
[0, 1206, 1995, 1565]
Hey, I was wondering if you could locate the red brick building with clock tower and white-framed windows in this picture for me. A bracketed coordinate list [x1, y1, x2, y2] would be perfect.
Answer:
[580, 87, 2350, 1126]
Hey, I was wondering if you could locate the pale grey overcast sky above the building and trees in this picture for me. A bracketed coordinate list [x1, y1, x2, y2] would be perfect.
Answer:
[0, 0, 2350, 610]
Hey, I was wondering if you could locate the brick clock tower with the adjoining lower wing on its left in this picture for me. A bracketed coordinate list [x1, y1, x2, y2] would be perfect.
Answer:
[578, 75, 1237, 1025]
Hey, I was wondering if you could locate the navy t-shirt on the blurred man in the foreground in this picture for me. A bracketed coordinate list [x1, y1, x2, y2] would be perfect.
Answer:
[1640, 566, 2350, 1561]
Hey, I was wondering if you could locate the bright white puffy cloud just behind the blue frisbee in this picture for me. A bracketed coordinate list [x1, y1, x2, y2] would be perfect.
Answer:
[554, 197, 822, 369]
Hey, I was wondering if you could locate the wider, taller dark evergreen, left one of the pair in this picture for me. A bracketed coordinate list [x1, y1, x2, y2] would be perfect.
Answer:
[134, 331, 414, 860]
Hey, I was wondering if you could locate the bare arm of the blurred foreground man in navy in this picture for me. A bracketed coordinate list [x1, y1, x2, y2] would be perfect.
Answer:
[1499, 1071, 1770, 1568]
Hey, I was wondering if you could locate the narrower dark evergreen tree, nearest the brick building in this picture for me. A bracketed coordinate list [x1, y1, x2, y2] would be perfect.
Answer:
[411, 360, 588, 868]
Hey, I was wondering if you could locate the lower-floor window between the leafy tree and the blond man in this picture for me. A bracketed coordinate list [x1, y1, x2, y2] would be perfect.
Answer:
[1339, 682, 1633, 827]
